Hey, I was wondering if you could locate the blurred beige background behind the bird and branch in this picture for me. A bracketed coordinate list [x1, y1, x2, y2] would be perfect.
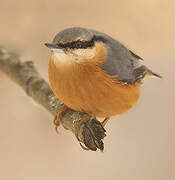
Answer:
[0, 0, 175, 180]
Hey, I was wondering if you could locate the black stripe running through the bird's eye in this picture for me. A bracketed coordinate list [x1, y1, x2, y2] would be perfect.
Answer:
[57, 36, 106, 49]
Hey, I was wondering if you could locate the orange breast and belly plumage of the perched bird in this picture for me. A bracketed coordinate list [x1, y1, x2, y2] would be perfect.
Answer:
[49, 43, 140, 117]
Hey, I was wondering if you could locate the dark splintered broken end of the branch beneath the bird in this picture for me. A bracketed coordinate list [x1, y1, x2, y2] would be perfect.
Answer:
[76, 115, 106, 151]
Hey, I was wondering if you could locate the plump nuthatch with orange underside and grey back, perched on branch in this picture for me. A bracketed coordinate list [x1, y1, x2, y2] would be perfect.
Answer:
[45, 27, 161, 149]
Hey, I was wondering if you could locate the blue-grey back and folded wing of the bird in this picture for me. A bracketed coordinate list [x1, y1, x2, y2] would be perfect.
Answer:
[91, 30, 148, 84]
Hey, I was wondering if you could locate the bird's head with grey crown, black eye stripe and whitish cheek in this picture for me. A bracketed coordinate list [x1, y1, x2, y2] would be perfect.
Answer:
[45, 27, 104, 62]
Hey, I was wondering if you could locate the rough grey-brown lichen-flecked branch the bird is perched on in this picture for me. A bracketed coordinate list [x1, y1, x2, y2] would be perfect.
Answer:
[0, 47, 105, 151]
